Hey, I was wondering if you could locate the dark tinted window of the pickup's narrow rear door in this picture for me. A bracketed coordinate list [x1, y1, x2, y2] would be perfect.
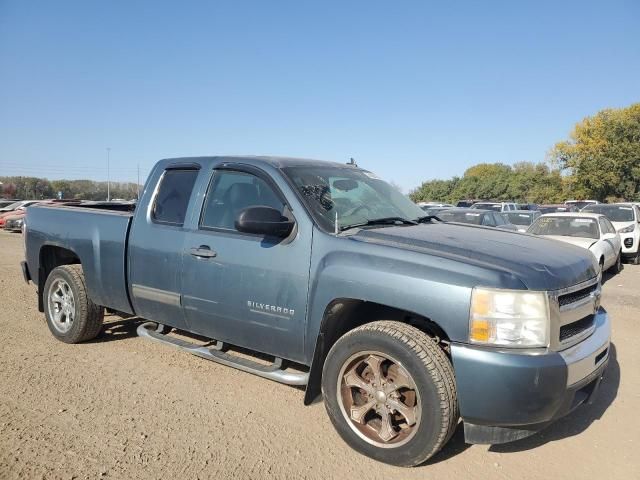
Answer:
[151, 169, 198, 226]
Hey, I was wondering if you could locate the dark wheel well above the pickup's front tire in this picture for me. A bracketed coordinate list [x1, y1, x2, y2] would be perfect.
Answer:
[304, 298, 449, 405]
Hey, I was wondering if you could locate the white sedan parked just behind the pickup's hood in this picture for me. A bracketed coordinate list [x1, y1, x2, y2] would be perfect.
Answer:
[527, 212, 622, 273]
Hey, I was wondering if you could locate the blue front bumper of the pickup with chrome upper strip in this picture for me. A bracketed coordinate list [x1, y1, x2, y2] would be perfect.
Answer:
[451, 310, 611, 443]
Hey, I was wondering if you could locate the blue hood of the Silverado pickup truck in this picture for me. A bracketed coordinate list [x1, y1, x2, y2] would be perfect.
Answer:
[351, 223, 597, 290]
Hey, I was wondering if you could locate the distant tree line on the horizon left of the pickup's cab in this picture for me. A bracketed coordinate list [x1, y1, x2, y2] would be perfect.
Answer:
[0, 176, 142, 200]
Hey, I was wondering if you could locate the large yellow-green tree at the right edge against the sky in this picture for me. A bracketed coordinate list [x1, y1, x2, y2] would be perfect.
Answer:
[551, 103, 640, 200]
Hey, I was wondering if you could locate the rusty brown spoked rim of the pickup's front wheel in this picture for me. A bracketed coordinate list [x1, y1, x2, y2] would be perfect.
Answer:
[337, 352, 420, 448]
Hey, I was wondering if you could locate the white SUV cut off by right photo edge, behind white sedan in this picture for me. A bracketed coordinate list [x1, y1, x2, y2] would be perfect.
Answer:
[581, 203, 640, 265]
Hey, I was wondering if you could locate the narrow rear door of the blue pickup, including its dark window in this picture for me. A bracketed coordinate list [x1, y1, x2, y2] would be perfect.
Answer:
[128, 164, 199, 329]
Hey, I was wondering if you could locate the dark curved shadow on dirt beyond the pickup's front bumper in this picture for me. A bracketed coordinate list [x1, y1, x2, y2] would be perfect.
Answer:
[489, 343, 620, 453]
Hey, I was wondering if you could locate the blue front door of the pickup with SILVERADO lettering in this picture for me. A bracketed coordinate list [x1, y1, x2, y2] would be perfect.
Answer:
[182, 164, 311, 360]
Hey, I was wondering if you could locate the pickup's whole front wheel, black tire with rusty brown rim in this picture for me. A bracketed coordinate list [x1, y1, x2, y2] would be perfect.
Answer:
[322, 321, 458, 467]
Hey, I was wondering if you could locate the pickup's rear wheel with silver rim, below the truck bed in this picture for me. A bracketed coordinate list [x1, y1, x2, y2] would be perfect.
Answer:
[43, 265, 104, 343]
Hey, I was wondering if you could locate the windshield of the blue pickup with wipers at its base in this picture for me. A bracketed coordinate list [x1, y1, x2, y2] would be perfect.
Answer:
[282, 166, 425, 232]
